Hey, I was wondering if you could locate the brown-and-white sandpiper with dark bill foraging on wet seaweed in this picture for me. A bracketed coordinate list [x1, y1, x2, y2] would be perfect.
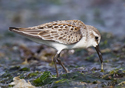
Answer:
[9, 20, 103, 76]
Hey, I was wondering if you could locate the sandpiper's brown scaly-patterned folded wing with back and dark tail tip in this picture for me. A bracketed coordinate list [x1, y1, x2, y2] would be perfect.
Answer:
[10, 20, 86, 44]
